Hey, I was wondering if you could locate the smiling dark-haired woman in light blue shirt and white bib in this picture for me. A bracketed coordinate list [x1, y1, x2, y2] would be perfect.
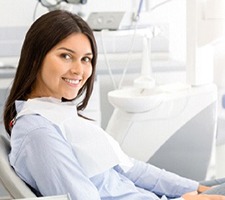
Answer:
[4, 10, 224, 200]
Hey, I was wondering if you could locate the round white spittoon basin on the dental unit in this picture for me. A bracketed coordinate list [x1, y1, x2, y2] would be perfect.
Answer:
[108, 88, 165, 113]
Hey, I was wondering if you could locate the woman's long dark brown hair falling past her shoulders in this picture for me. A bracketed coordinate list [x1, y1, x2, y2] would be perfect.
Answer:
[4, 10, 97, 135]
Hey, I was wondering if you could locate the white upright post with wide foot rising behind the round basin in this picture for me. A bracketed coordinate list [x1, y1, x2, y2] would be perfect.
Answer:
[134, 35, 155, 89]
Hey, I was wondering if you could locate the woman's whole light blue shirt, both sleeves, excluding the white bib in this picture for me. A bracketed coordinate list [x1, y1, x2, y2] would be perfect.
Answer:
[9, 101, 199, 200]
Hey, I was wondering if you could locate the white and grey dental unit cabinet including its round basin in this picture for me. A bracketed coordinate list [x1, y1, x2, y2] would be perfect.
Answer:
[106, 84, 217, 181]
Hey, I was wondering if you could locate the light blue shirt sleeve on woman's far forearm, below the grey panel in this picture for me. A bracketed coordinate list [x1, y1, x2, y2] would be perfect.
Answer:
[116, 159, 199, 199]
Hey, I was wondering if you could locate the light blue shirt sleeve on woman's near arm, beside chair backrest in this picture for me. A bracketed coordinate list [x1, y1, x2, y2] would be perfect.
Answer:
[11, 122, 100, 200]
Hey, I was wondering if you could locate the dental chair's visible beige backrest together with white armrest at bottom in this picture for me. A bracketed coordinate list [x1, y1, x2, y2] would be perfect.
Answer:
[0, 133, 70, 200]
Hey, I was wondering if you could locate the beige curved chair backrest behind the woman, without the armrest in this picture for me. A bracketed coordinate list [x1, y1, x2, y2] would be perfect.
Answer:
[0, 133, 36, 199]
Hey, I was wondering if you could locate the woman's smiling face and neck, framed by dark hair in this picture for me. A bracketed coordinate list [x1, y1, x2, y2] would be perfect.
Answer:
[31, 33, 93, 99]
